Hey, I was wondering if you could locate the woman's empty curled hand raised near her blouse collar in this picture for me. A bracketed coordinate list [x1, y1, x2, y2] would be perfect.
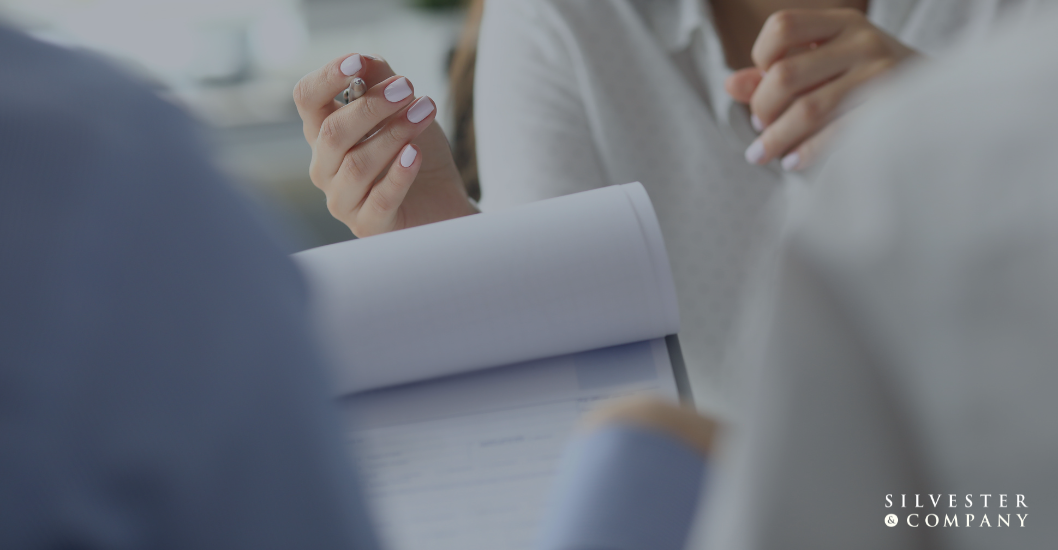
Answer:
[725, 8, 916, 170]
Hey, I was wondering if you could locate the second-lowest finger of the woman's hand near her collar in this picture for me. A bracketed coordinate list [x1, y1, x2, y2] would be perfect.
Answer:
[746, 63, 884, 164]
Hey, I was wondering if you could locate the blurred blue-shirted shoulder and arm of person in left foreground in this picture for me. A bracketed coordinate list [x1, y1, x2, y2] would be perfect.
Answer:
[0, 36, 378, 550]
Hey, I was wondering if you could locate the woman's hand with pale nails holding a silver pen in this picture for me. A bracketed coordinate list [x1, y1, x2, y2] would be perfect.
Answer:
[294, 54, 477, 237]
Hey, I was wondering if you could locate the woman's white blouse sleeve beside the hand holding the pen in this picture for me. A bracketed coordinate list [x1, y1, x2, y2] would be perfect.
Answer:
[474, 0, 609, 209]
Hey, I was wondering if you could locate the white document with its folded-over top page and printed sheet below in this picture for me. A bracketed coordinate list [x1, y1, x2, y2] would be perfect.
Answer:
[294, 183, 679, 550]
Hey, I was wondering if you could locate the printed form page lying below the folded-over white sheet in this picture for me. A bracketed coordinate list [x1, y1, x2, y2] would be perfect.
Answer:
[344, 338, 676, 550]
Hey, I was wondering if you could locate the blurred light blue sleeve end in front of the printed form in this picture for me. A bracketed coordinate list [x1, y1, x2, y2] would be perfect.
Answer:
[540, 424, 706, 550]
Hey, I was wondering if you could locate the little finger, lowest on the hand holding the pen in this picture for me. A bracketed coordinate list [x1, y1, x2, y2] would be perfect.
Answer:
[357, 144, 422, 237]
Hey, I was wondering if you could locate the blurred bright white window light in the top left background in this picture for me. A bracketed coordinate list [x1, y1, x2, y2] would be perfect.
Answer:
[0, 0, 308, 87]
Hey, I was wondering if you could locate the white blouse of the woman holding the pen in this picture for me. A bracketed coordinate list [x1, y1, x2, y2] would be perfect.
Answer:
[474, 0, 1036, 413]
